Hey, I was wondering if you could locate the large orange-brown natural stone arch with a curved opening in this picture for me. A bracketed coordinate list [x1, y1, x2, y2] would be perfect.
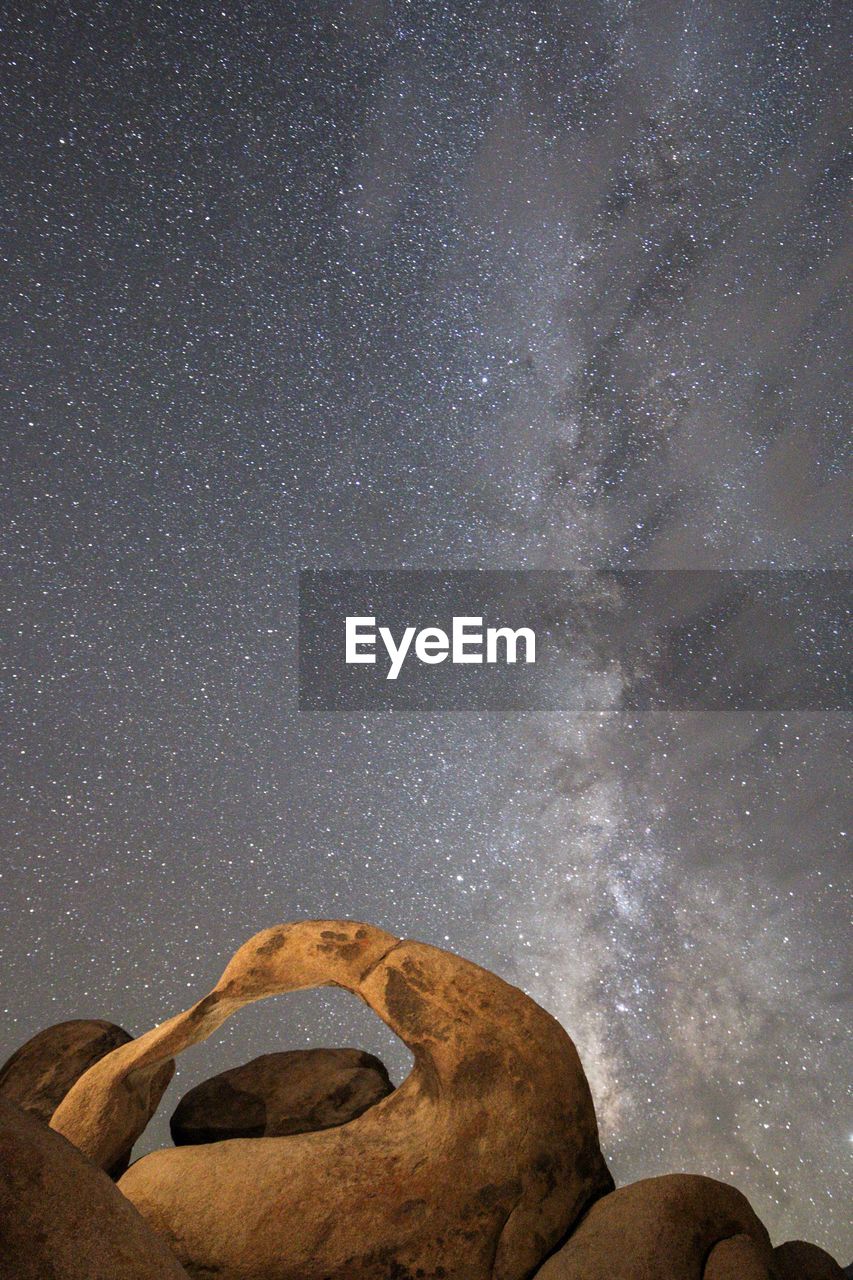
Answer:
[51, 920, 612, 1280]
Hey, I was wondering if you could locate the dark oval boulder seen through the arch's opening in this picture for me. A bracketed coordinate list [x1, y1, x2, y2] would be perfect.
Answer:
[169, 1048, 393, 1147]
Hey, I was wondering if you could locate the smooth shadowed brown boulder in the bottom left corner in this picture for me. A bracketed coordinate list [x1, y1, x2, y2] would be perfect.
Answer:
[0, 1100, 186, 1280]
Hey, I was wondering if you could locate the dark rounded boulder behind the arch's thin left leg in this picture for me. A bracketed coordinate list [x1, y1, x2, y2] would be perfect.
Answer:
[0, 1018, 174, 1178]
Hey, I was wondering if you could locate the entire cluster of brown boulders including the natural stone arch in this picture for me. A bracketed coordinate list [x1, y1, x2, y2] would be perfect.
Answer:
[0, 920, 845, 1280]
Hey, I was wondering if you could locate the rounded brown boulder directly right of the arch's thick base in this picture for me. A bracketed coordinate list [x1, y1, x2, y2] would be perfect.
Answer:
[537, 1174, 772, 1280]
